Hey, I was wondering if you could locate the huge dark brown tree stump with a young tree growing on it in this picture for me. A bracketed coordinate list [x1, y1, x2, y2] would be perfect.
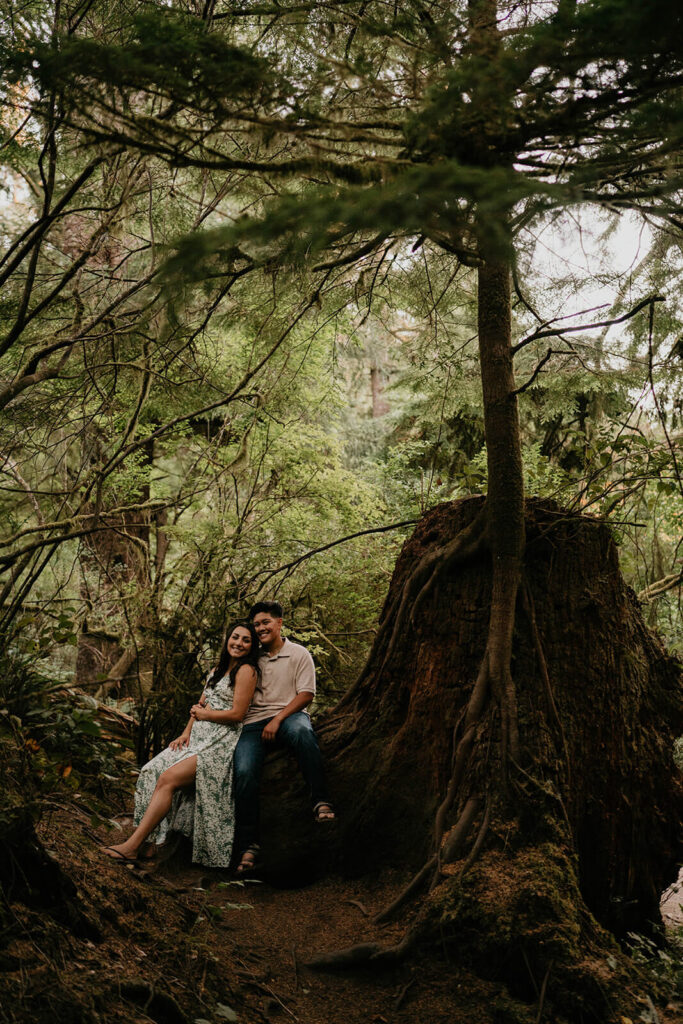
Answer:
[263, 498, 683, 999]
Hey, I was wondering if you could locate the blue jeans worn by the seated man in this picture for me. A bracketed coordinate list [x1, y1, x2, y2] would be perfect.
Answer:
[234, 711, 328, 854]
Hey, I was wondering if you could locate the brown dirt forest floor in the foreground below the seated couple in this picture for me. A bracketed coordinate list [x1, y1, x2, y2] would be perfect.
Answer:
[0, 795, 681, 1024]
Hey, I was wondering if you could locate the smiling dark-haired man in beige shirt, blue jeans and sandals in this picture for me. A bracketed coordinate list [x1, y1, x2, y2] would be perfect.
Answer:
[234, 601, 335, 874]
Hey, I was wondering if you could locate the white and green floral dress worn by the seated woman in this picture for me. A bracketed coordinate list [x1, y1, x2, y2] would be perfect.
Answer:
[135, 675, 242, 867]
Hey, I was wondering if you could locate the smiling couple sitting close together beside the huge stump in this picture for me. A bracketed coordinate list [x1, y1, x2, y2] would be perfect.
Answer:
[102, 601, 335, 874]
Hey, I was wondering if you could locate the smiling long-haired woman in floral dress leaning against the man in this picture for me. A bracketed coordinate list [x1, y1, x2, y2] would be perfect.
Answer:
[102, 622, 259, 867]
